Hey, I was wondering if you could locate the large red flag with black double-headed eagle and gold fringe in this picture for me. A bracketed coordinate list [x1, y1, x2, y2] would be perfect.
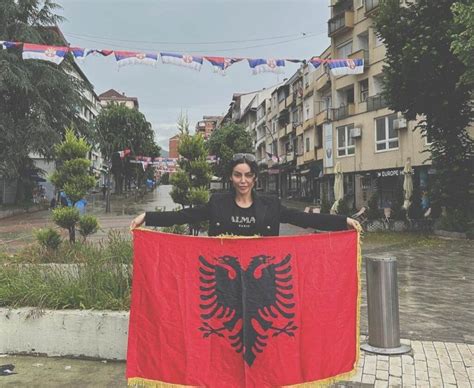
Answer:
[126, 229, 360, 388]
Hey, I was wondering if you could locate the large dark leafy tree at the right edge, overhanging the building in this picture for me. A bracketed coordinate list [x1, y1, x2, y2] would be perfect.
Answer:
[376, 0, 473, 228]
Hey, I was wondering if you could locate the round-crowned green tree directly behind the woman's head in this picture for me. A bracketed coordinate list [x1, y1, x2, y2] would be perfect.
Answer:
[209, 123, 254, 185]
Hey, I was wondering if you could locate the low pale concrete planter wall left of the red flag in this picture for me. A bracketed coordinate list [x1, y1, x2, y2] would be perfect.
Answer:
[0, 308, 129, 360]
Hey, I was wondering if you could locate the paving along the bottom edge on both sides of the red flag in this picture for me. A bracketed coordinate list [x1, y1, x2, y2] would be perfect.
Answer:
[0, 337, 474, 388]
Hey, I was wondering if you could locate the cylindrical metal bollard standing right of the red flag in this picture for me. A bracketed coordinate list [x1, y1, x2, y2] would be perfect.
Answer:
[361, 257, 411, 355]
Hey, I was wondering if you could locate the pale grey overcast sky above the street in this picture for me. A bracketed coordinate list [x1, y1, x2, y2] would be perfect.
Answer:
[57, 0, 330, 149]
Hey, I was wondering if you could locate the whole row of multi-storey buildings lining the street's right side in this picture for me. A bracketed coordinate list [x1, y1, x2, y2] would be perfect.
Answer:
[219, 0, 466, 212]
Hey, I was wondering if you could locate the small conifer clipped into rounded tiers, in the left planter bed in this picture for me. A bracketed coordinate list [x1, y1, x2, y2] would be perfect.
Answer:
[51, 129, 95, 242]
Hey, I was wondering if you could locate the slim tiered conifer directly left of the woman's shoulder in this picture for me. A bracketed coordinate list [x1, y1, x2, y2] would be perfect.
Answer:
[170, 114, 212, 235]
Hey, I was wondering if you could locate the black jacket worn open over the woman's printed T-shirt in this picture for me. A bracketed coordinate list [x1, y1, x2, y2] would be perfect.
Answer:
[145, 193, 347, 236]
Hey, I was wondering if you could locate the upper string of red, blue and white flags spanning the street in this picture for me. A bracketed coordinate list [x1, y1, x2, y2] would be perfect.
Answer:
[0, 40, 364, 76]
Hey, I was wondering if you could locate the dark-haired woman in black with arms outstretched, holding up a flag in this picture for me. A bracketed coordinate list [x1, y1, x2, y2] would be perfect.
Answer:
[131, 154, 360, 236]
